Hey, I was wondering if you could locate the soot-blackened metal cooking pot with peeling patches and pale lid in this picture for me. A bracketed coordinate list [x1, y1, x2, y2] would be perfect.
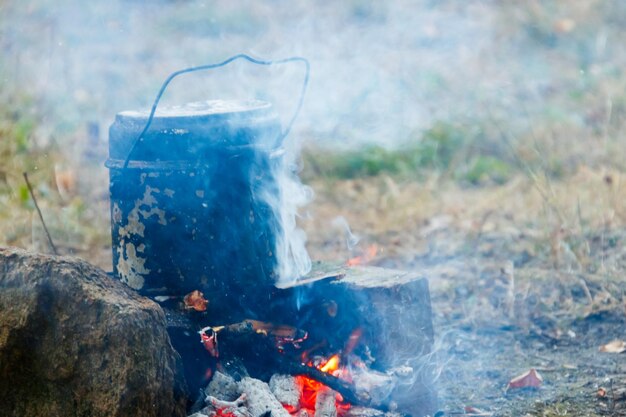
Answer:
[106, 100, 282, 297]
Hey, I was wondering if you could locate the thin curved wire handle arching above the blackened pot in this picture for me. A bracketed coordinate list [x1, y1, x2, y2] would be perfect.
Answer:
[122, 54, 311, 169]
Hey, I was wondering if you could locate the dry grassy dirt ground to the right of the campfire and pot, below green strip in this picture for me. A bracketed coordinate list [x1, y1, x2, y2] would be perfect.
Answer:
[305, 170, 626, 416]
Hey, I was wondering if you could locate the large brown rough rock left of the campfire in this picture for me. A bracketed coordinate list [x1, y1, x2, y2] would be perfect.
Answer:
[0, 249, 186, 417]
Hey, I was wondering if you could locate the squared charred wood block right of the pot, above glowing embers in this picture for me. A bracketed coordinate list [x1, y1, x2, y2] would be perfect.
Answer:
[267, 264, 437, 416]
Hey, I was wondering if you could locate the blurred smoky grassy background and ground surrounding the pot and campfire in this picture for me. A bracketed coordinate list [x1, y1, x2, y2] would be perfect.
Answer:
[0, 0, 626, 415]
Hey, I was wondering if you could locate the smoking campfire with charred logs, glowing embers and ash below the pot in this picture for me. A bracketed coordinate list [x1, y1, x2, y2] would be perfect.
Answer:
[160, 263, 434, 417]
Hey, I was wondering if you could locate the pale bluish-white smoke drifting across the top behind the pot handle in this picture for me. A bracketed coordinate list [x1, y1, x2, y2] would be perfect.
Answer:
[0, 0, 509, 146]
